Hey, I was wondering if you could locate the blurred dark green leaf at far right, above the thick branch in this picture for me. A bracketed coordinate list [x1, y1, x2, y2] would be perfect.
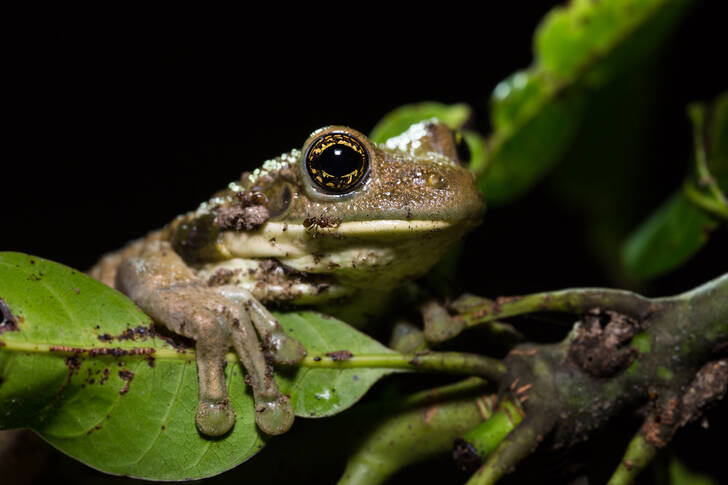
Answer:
[622, 191, 717, 279]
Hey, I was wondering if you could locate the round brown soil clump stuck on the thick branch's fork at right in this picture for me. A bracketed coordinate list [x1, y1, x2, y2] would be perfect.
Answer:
[569, 308, 641, 377]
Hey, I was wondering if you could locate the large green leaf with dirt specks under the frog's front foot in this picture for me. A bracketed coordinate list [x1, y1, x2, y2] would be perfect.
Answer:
[0, 253, 398, 480]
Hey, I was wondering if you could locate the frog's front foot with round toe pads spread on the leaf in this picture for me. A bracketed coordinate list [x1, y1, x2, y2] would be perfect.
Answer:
[130, 285, 306, 436]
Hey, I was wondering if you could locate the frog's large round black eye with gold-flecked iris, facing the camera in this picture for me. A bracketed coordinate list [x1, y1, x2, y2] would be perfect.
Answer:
[305, 132, 369, 194]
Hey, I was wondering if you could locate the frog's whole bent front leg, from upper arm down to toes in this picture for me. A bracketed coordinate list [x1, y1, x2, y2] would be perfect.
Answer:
[116, 241, 305, 436]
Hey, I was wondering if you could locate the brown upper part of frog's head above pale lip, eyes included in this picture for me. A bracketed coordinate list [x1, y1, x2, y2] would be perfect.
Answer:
[251, 119, 484, 227]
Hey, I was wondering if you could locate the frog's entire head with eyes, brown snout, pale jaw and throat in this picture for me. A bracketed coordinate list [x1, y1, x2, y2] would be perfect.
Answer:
[216, 119, 485, 286]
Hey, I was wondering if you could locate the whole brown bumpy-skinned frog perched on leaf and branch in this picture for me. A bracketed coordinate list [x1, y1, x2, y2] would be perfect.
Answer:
[89, 119, 485, 437]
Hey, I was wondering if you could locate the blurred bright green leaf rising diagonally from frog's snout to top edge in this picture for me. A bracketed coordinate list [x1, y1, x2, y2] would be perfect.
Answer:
[473, 0, 688, 206]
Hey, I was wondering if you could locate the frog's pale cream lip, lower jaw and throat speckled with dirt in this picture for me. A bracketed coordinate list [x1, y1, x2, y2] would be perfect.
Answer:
[221, 219, 478, 288]
